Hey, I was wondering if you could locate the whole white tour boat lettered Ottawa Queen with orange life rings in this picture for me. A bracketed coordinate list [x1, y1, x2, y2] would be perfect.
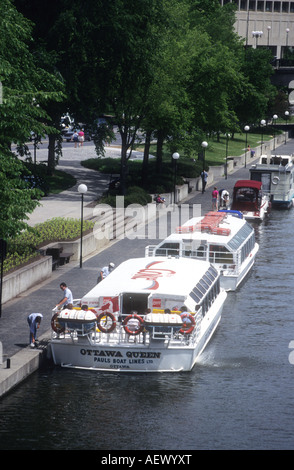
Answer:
[50, 257, 227, 372]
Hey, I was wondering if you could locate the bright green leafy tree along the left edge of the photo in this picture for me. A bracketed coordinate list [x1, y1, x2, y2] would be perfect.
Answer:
[0, 0, 64, 235]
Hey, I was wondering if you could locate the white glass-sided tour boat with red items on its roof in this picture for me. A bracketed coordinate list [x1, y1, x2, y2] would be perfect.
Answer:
[145, 210, 259, 291]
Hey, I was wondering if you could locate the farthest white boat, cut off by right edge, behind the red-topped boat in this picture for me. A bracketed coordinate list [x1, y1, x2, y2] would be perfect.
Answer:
[250, 155, 294, 209]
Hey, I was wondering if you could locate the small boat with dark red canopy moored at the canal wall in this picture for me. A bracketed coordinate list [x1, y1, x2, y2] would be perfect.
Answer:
[230, 180, 271, 222]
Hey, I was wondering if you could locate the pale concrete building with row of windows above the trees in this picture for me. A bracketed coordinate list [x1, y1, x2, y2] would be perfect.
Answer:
[220, 0, 294, 60]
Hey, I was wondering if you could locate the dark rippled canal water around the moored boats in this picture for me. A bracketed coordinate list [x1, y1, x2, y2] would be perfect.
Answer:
[0, 209, 294, 451]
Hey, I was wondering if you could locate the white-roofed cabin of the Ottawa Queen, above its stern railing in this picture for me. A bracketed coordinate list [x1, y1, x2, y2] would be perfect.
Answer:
[81, 257, 220, 318]
